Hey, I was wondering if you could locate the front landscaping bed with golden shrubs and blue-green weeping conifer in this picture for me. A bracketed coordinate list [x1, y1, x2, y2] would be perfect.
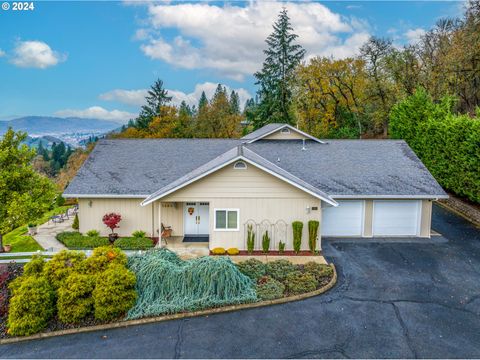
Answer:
[0, 246, 335, 340]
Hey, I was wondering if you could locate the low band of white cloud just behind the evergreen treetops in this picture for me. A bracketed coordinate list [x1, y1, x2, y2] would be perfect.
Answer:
[99, 82, 252, 106]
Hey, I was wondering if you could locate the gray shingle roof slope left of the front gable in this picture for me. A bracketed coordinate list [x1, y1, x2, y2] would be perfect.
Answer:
[64, 139, 239, 196]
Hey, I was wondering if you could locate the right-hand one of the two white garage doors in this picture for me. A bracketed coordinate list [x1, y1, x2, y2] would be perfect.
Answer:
[373, 200, 421, 236]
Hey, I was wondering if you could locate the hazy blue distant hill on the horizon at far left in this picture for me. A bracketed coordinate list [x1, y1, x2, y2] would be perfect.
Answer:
[0, 116, 121, 136]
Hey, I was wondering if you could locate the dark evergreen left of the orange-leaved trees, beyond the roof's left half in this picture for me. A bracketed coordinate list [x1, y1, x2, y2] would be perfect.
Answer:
[135, 79, 172, 130]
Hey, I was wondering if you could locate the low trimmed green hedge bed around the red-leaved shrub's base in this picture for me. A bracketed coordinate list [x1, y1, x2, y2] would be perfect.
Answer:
[57, 231, 155, 250]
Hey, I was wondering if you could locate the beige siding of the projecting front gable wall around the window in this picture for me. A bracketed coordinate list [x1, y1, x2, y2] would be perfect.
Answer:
[162, 164, 321, 249]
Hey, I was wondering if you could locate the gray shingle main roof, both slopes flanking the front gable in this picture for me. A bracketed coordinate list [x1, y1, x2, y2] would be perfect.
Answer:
[64, 139, 445, 197]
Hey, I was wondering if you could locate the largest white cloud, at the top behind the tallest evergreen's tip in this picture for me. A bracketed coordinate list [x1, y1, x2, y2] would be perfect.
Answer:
[136, 1, 368, 80]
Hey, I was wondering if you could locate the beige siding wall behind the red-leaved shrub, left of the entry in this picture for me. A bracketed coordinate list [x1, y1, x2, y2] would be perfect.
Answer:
[78, 198, 158, 236]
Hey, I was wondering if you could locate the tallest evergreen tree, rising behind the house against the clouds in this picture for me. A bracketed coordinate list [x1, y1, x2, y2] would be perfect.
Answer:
[253, 8, 305, 128]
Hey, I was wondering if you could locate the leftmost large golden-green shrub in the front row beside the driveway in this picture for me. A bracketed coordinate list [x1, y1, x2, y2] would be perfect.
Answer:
[8, 276, 55, 336]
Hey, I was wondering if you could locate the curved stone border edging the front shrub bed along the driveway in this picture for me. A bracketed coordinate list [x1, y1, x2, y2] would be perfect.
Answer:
[0, 264, 337, 345]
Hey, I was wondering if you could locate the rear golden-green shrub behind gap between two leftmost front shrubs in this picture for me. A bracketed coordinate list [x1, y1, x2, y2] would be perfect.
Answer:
[43, 250, 86, 289]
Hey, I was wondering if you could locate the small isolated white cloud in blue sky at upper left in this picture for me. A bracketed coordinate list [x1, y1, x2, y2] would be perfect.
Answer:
[11, 41, 66, 69]
